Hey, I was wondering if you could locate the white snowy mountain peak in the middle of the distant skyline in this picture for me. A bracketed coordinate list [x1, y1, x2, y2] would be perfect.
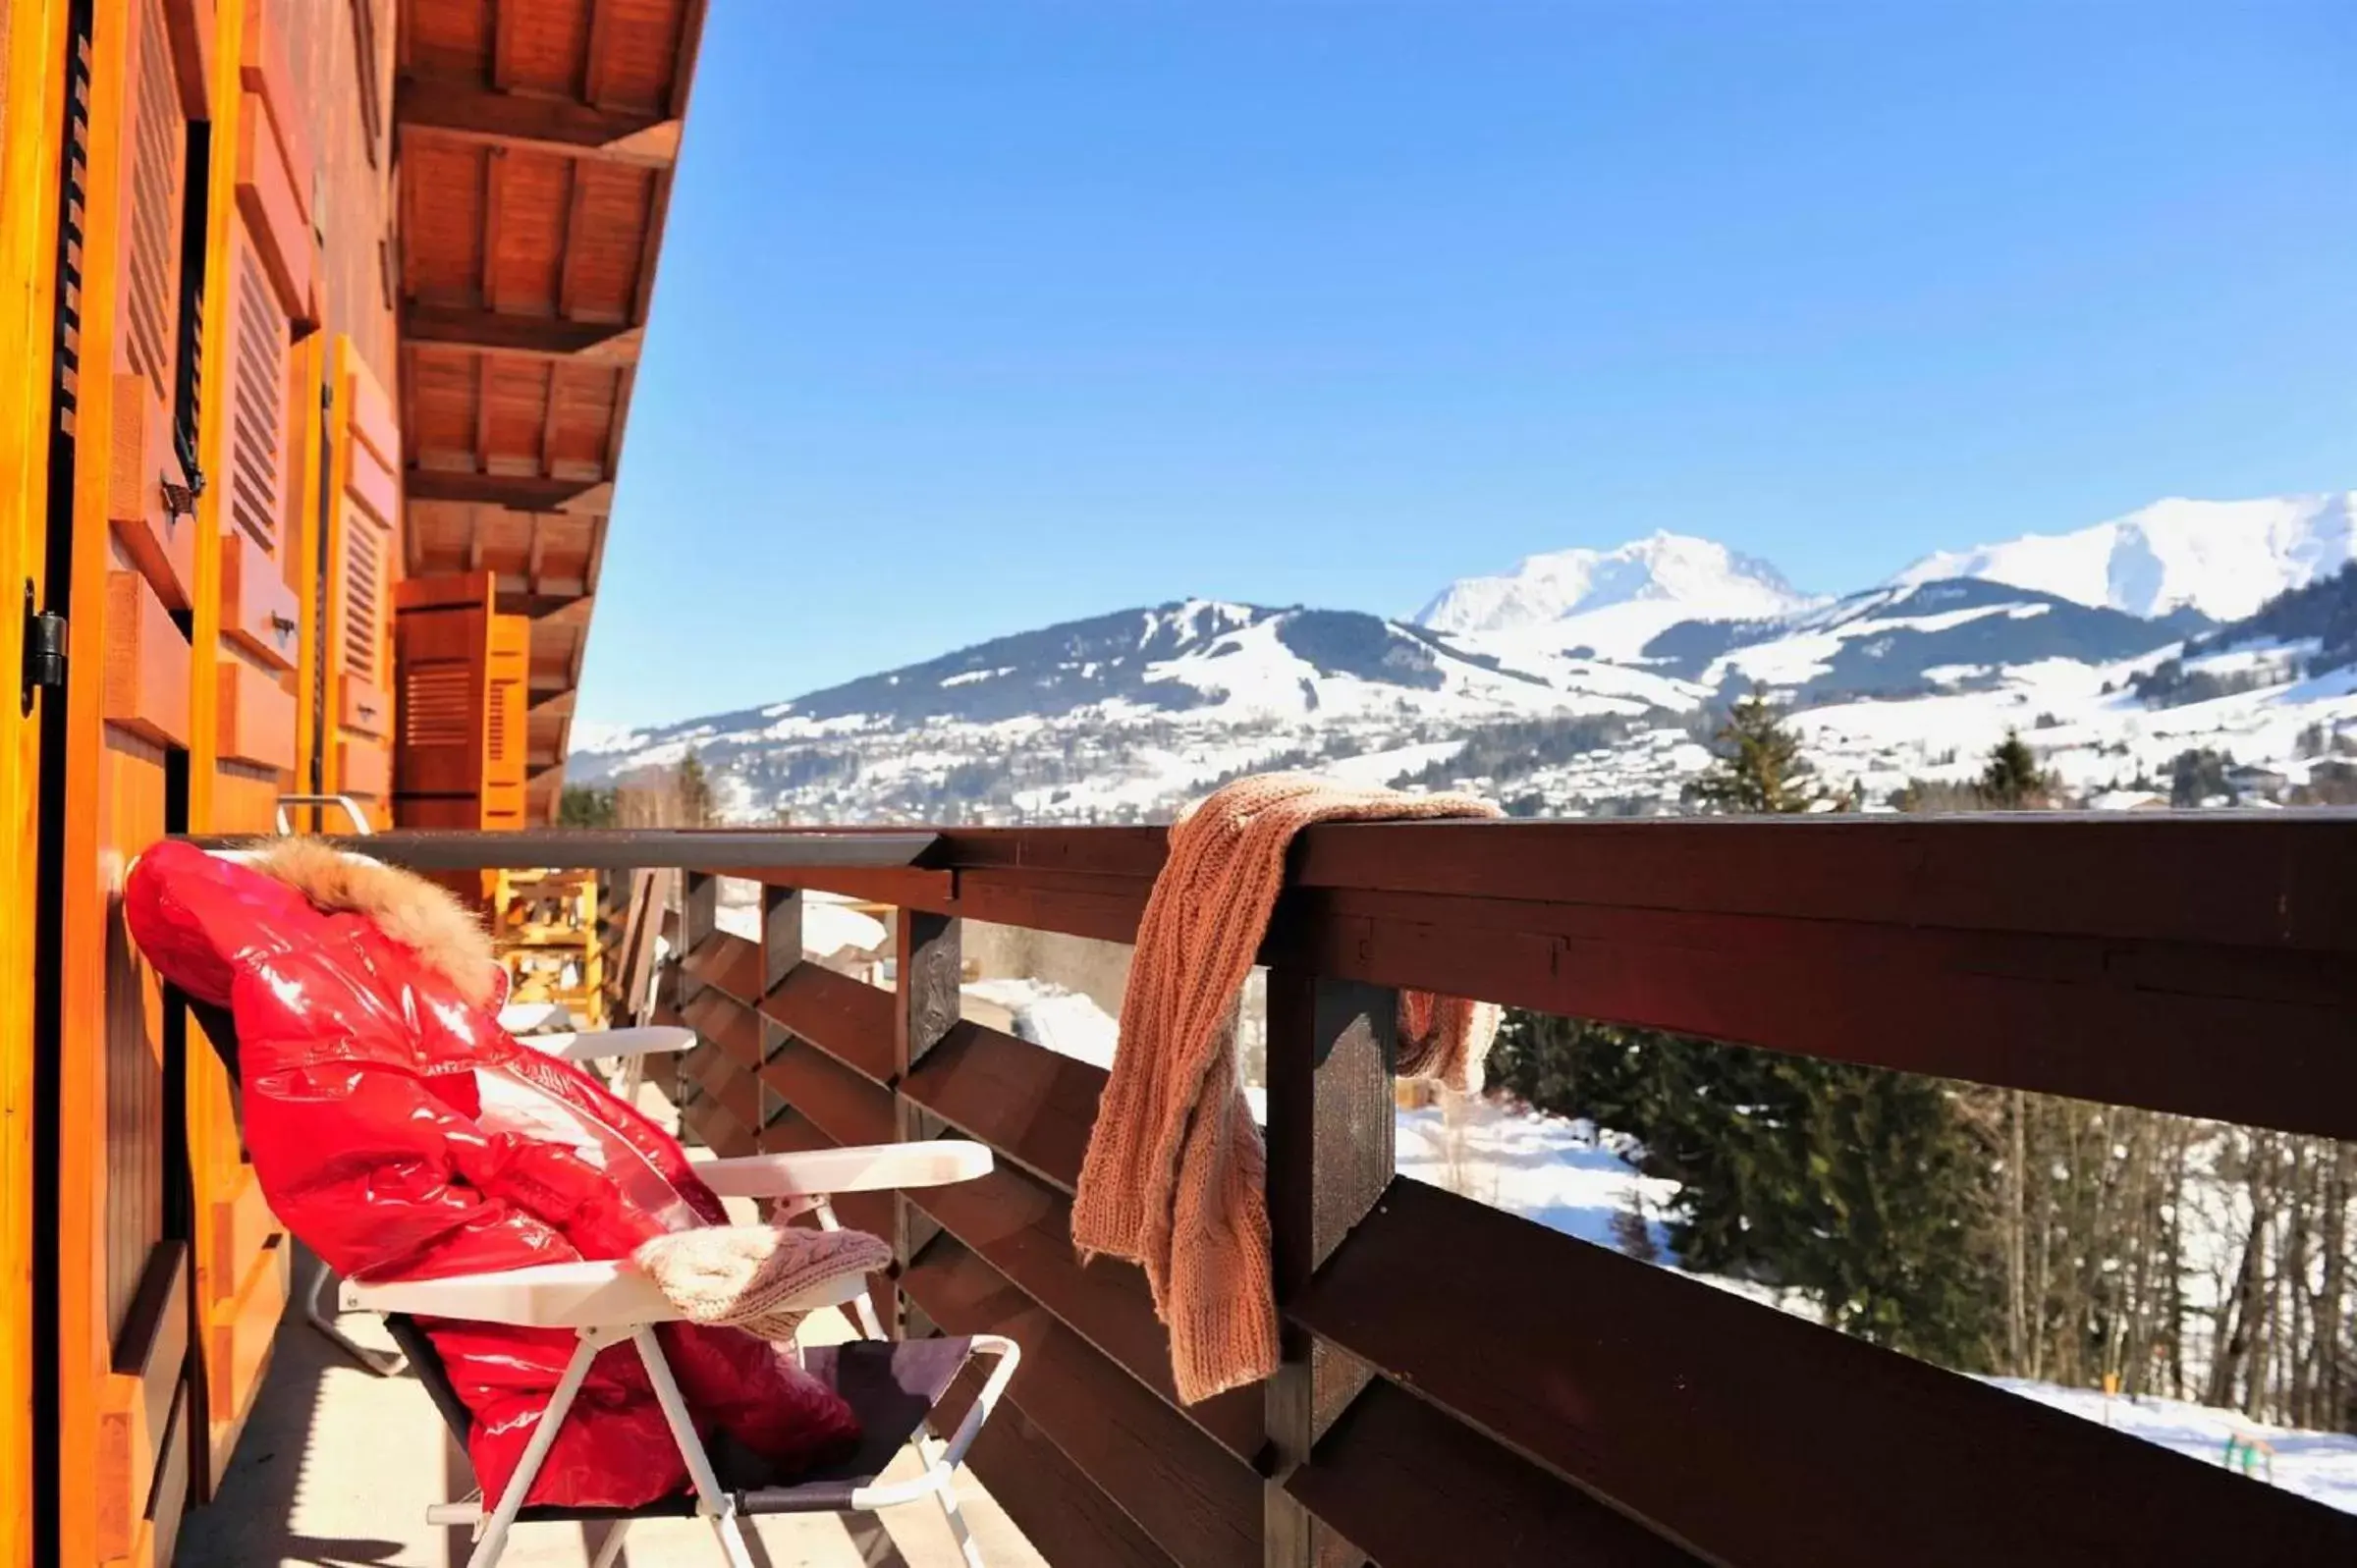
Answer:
[1416, 533, 1815, 660]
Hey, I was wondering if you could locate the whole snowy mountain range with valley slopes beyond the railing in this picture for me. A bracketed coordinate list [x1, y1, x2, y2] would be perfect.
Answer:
[571, 495, 2357, 821]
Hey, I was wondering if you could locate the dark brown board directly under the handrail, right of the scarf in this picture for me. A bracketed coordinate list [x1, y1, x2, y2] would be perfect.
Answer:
[1271, 892, 2357, 1137]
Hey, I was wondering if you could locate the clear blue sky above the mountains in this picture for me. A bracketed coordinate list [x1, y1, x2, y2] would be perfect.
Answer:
[582, 0, 2357, 722]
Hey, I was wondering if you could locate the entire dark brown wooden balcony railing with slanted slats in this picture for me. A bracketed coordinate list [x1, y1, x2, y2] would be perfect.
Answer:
[244, 811, 2357, 1568]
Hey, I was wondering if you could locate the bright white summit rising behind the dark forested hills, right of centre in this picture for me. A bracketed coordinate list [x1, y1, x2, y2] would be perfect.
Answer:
[1416, 533, 1810, 632]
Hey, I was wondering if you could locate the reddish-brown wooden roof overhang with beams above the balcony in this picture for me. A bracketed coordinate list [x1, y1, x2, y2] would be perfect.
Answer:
[394, 0, 705, 818]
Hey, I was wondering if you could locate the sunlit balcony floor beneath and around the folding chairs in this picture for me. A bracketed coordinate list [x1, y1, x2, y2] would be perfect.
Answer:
[172, 1089, 1044, 1568]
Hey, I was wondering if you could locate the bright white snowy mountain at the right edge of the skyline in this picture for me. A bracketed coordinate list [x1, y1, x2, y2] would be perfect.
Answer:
[1891, 491, 2357, 621]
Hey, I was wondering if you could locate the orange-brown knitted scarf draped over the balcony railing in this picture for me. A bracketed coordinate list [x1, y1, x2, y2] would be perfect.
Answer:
[1072, 774, 1499, 1405]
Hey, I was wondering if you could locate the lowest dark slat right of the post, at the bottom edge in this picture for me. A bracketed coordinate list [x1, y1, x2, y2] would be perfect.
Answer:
[1285, 1381, 1699, 1568]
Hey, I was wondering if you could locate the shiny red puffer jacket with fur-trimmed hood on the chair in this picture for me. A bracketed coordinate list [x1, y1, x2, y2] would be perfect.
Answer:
[125, 839, 858, 1507]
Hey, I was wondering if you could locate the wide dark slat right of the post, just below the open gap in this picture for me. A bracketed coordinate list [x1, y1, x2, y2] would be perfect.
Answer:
[1287, 1179, 2357, 1568]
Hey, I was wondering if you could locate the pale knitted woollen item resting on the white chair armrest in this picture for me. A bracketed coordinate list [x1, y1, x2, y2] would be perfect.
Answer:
[631, 1226, 891, 1344]
